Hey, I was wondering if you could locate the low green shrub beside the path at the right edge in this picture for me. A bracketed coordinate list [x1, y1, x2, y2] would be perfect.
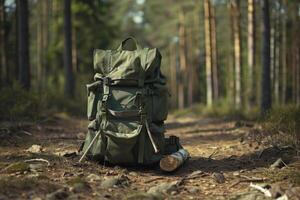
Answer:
[262, 106, 300, 148]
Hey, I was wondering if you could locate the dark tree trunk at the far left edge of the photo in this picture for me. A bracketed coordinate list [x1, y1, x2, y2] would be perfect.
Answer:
[0, 0, 8, 86]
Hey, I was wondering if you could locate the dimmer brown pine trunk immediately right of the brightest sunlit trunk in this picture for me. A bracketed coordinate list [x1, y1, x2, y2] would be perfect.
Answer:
[210, 5, 219, 101]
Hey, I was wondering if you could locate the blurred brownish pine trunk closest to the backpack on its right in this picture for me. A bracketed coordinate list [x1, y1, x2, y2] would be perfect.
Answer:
[178, 11, 187, 109]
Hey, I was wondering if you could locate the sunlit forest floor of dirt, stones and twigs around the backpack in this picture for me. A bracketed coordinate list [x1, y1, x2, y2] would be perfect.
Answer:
[0, 116, 300, 200]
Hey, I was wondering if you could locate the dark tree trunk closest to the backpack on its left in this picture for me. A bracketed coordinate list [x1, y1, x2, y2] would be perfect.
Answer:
[64, 0, 74, 98]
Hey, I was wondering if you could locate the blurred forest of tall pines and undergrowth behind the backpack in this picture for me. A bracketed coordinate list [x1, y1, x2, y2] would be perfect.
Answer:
[0, 0, 300, 122]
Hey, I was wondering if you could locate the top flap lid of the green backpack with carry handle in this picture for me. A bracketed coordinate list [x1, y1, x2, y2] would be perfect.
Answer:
[94, 39, 161, 84]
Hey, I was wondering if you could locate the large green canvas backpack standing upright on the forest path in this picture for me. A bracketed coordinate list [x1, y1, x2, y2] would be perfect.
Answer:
[82, 37, 177, 165]
